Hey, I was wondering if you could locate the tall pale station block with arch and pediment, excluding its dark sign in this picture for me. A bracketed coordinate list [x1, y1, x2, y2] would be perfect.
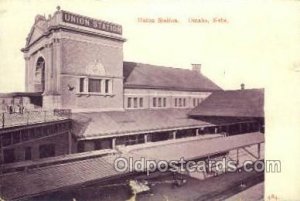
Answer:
[22, 11, 125, 111]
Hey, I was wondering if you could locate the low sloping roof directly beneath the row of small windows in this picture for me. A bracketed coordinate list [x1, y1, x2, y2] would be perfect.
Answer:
[72, 109, 211, 139]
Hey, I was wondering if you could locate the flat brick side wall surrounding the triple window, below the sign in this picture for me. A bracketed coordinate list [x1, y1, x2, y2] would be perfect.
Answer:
[60, 36, 123, 111]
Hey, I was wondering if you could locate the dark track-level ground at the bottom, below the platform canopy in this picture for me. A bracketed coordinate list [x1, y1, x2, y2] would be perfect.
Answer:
[32, 168, 263, 201]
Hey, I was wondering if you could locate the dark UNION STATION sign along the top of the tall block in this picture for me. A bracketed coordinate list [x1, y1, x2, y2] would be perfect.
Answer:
[62, 11, 122, 34]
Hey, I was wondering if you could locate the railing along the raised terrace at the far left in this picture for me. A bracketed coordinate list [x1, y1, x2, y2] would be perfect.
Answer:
[0, 110, 71, 128]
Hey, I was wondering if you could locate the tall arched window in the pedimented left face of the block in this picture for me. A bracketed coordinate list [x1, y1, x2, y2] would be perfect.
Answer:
[35, 57, 45, 92]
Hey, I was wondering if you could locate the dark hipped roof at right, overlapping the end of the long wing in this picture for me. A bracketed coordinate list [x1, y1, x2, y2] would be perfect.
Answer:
[189, 89, 264, 117]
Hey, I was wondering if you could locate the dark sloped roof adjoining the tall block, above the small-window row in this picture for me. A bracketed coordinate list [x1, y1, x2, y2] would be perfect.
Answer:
[123, 62, 221, 91]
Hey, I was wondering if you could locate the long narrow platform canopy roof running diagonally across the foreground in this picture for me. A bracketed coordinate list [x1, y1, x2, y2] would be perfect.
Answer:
[0, 133, 264, 200]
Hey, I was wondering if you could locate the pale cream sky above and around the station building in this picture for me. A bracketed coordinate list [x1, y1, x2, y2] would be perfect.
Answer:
[0, 0, 300, 92]
